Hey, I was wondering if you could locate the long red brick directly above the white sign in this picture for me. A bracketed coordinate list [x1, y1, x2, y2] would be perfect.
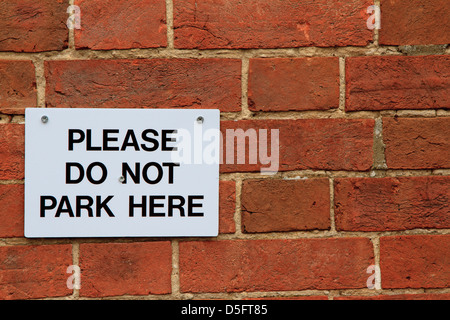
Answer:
[45, 59, 241, 111]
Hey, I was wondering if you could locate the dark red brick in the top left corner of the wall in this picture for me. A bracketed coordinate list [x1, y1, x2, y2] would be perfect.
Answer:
[0, 0, 69, 52]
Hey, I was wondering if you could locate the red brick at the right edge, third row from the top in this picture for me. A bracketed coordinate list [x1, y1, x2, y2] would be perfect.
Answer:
[383, 117, 450, 169]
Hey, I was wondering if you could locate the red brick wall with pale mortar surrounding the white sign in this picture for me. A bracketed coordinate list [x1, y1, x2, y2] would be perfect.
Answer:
[0, 0, 450, 300]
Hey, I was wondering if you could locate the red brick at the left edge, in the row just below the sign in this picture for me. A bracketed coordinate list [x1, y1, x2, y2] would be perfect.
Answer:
[0, 245, 72, 300]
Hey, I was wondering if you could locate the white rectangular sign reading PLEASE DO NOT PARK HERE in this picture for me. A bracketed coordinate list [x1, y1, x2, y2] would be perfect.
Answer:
[25, 108, 220, 238]
